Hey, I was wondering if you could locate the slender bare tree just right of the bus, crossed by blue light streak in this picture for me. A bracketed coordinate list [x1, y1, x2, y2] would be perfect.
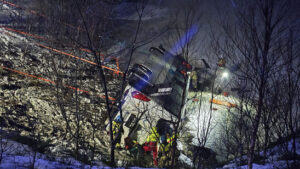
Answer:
[155, 0, 202, 166]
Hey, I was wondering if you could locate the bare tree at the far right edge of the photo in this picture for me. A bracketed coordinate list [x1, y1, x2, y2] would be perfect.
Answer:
[280, 29, 300, 168]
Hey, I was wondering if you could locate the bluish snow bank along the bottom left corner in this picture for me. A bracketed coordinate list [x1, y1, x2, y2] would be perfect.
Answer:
[0, 139, 159, 169]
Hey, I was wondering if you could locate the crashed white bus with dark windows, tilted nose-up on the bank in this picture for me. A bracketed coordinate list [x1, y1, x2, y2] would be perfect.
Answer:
[108, 47, 191, 145]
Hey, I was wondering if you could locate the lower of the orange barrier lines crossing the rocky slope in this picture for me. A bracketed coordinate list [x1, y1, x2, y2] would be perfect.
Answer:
[0, 65, 116, 101]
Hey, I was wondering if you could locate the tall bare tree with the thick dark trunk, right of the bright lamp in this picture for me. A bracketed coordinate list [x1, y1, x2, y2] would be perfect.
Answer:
[217, 0, 296, 168]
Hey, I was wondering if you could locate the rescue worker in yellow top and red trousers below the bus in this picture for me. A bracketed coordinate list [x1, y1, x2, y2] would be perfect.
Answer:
[143, 127, 159, 166]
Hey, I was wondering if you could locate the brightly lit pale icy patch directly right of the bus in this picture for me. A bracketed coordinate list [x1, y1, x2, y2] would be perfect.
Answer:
[187, 92, 236, 149]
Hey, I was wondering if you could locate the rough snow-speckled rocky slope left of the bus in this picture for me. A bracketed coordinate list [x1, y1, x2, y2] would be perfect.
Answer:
[0, 12, 118, 164]
